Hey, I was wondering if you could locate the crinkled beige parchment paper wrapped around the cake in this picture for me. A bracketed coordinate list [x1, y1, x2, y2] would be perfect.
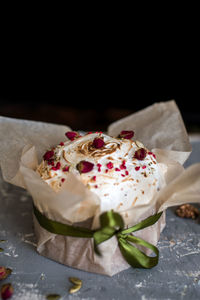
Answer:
[0, 101, 200, 276]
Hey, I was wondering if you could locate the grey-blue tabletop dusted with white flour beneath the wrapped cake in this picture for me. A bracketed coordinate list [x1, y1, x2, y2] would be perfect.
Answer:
[0, 140, 200, 300]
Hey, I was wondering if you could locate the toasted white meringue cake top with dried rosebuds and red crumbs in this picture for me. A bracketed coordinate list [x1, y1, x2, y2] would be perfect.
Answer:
[37, 130, 161, 211]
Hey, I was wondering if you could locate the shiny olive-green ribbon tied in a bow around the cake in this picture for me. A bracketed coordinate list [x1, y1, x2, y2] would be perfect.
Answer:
[33, 206, 162, 269]
